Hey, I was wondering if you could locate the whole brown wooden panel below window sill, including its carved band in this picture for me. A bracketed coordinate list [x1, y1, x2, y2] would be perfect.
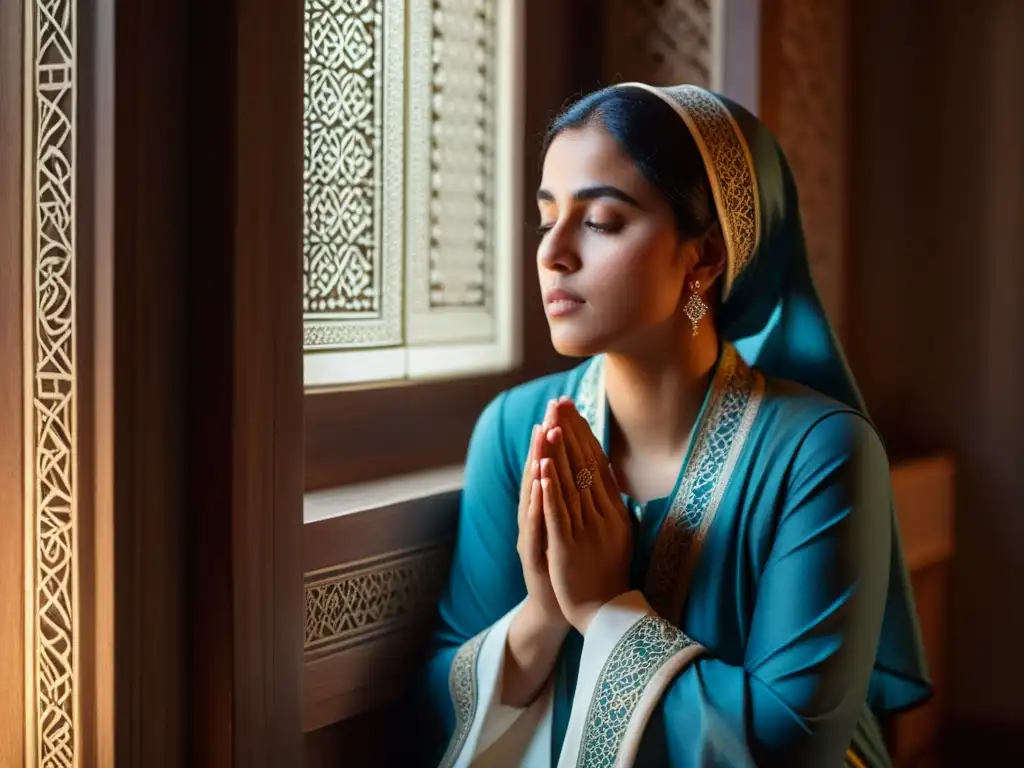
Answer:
[302, 489, 460, 732]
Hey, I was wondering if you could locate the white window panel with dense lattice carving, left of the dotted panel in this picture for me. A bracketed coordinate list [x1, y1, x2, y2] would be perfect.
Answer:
[303, 0, 404, 349]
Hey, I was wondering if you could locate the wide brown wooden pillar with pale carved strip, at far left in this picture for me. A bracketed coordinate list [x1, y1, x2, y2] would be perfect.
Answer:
[0, 0, 303, 768]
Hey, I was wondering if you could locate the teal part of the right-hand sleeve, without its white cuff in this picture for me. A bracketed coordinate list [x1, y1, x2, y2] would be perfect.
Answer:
[645, 413, 891, 768]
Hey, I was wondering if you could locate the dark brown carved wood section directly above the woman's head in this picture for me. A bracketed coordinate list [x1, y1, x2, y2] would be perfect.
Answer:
[604, 0, 715, 87]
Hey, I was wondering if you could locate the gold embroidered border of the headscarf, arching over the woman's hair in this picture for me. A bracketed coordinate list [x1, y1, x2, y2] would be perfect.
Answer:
[606, 83, 761, 299]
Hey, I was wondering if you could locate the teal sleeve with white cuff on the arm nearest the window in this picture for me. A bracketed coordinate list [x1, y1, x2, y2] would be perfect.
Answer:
[420, 394, 550, 765]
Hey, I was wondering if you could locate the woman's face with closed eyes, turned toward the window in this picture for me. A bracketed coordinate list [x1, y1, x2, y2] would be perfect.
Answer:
[537, 126, 696, 356]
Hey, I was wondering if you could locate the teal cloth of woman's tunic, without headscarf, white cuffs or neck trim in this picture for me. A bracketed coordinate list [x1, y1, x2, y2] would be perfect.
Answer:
[419, 350, 917, 767]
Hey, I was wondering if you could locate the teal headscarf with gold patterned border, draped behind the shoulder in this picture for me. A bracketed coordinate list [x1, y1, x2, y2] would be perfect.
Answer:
[621, 83, 931, 714]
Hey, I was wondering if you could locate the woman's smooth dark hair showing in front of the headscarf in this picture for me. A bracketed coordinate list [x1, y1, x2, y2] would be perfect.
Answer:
[542, 86, 718, 239]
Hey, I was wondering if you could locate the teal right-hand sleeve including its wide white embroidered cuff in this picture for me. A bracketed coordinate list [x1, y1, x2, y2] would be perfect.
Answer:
[563, 413, 891, 768]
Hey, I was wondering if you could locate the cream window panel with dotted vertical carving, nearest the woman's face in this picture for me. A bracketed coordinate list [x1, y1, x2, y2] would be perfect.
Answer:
[406, 0, 505, 344]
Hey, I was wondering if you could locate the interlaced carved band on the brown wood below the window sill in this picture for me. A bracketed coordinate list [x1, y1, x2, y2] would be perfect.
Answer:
[305, 547, 449, 653]
